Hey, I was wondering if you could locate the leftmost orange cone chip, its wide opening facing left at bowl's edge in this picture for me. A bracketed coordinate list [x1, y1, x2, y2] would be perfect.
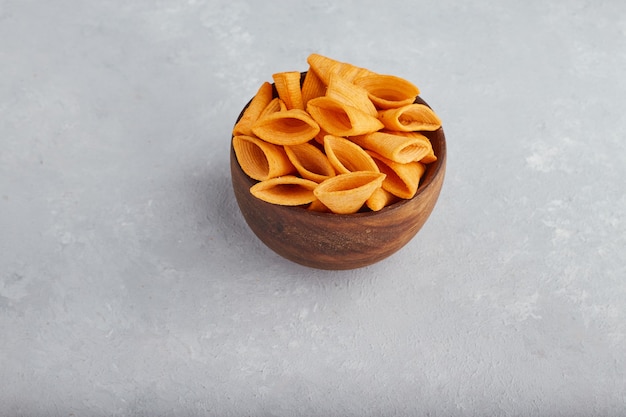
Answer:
[233, 135, 296, 181]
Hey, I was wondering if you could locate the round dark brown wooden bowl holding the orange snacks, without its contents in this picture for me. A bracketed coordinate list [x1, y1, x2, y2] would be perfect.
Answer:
[230, 87, 446, 270]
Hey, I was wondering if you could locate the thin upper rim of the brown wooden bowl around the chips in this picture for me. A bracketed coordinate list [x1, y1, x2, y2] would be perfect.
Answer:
[230, 71, 447, 218]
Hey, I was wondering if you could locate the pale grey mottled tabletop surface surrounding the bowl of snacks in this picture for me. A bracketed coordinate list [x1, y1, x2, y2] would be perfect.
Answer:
[0, 0, 626, 416]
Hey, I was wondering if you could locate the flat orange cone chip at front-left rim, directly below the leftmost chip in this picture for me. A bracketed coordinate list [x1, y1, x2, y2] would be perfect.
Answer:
[250, 175, 317, 206]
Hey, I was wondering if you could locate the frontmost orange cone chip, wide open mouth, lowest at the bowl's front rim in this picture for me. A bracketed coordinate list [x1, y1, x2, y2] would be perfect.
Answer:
[313, 171, 385, 214]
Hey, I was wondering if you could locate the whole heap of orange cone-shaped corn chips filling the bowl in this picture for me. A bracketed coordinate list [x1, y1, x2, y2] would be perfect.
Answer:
[233, 54, 441, 214]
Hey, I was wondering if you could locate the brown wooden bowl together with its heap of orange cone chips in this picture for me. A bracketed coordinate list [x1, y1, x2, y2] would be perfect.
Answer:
[231, 54, 445, 269]
